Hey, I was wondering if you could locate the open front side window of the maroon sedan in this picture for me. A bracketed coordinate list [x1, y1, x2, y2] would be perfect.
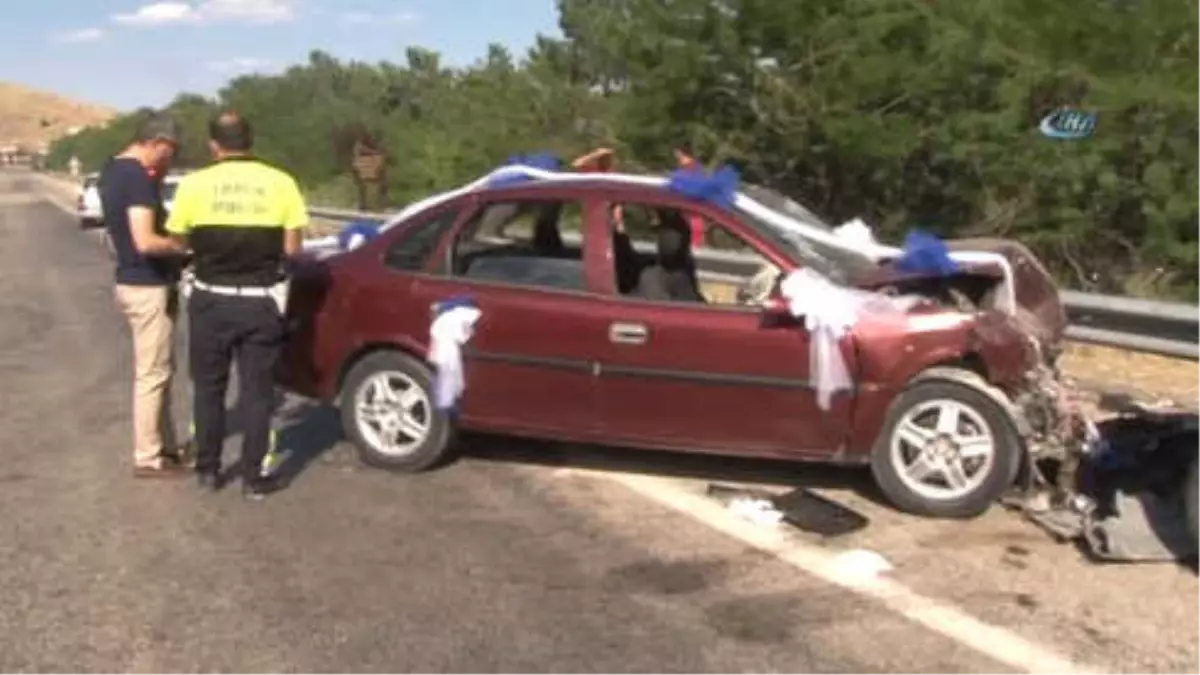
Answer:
[608, 202, 780, 307]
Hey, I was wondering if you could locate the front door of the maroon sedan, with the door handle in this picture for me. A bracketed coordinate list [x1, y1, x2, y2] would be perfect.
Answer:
[588, 190, 854, 458]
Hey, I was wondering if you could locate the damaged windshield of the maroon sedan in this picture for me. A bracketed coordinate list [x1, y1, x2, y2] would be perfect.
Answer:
[737, 185, 876, 283]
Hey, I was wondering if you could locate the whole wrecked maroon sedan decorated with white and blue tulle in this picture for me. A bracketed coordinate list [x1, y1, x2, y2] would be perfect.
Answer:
[281, 166, 1079, 518]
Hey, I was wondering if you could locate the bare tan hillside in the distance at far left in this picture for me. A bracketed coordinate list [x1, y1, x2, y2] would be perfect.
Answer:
[0, 82, 118, 148]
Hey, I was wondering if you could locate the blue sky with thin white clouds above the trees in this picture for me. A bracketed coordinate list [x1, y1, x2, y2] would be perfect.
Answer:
[0, 0, 559, 110]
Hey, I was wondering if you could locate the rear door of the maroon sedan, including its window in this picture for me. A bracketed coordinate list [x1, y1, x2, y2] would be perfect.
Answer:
[400, 189, 607, 438]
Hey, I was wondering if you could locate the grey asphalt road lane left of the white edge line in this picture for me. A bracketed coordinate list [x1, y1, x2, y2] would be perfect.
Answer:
[0, 173, 1036, 675]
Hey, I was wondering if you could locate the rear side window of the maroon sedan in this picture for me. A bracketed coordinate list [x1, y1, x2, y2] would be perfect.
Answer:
[450, 199, 587, 291]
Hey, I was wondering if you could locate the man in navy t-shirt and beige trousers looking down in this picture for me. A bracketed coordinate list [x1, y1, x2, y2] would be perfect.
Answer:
[100, 115, 187, 477]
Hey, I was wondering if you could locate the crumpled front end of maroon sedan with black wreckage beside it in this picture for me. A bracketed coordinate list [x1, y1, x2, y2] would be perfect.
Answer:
[876, 240, 1200, 562]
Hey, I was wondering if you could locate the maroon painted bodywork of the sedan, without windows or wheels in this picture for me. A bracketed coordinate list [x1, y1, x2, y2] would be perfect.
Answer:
[280, 181, 1051, 461]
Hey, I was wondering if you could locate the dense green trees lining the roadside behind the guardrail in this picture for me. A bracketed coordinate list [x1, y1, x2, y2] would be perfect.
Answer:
[50, 0, 1200, 298]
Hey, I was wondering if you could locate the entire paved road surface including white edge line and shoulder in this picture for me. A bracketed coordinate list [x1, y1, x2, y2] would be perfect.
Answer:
[9, 172, 1200, 675]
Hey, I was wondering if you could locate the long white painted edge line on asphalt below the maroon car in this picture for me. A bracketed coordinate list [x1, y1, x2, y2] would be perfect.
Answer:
[590, 470, 1104, 675]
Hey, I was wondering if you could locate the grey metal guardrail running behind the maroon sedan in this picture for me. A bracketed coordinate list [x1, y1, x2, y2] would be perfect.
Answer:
[310, 207, 1200, 360]
